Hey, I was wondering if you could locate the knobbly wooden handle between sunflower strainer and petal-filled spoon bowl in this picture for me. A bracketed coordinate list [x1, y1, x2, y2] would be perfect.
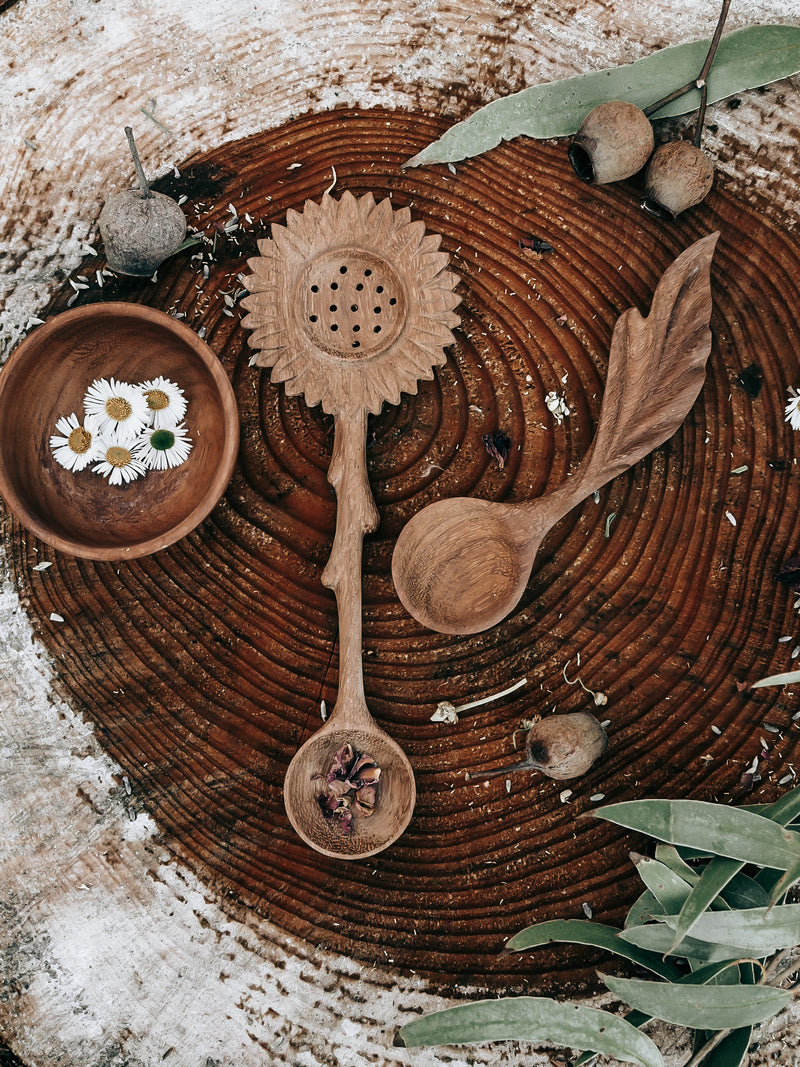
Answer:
[322, 408, 379, 727]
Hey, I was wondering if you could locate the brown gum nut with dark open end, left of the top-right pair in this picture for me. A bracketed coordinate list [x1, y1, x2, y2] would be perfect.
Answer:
[569, 100, 655, 186]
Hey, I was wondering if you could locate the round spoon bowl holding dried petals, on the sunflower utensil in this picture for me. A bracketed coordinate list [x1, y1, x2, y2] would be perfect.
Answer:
[284, 719, 417, 859]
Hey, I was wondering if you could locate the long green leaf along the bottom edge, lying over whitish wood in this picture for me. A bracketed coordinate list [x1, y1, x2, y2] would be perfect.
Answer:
[400, 987, 669, 1067]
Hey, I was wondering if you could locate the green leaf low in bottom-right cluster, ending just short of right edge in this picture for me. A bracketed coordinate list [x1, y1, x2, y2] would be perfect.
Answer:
[601, 974, 791, 1030]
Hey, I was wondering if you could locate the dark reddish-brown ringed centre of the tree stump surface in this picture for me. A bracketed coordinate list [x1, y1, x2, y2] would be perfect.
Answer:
[4, 111, 800, 990]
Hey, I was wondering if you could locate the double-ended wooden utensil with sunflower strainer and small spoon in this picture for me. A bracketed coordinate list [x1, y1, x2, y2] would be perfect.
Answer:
[242, 192, 460, 859]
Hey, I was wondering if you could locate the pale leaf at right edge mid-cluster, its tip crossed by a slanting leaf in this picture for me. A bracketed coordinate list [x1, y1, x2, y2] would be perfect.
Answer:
[659, 904, 800, 958]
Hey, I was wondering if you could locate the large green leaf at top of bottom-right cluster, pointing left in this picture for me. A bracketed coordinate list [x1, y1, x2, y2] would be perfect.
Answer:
[592, 800, 800, 871]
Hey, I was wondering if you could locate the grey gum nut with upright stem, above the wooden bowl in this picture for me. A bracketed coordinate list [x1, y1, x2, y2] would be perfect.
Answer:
[99, 189, 186, 275]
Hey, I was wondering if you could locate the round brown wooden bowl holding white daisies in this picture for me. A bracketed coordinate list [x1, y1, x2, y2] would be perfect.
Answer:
[0, 303, 239, 559]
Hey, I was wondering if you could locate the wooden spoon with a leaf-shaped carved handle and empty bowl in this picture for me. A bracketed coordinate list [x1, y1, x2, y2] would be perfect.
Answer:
[391, 234, 719, 634]
